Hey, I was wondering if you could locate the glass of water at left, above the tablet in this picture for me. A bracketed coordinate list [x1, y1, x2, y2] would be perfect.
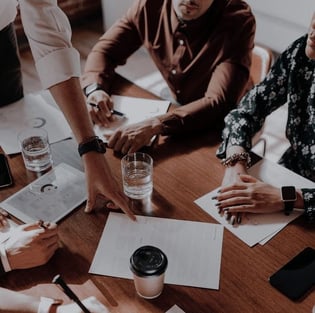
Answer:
[18, 128, 53, 172]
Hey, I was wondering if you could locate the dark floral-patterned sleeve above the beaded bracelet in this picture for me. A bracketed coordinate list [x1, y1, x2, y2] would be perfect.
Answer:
[217, 37, 300, 158]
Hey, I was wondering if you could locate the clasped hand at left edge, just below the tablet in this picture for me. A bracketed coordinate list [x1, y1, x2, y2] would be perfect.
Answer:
[4, 223, 58, 270]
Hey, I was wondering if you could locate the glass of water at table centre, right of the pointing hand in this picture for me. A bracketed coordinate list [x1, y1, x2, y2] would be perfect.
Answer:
[121, 152, 153, 199]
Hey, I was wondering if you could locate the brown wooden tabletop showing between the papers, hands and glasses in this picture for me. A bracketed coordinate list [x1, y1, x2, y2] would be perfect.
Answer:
[0, 75, 315, 313]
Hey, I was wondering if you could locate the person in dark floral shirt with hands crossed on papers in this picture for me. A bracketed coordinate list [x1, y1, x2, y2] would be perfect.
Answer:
[215, 13, 315, 224]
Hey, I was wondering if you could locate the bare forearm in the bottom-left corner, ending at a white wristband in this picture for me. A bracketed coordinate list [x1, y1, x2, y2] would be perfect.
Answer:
[0, 287, 40, 313]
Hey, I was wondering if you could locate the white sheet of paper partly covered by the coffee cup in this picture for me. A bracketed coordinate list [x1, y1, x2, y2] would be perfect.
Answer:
[89, 212, 223, 289]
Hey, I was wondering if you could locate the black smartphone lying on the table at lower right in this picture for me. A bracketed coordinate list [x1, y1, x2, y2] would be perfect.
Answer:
[269, 247, 315, 301]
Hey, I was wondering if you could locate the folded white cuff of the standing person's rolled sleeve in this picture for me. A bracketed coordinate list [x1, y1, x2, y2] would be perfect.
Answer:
[36, 48, 81, 89]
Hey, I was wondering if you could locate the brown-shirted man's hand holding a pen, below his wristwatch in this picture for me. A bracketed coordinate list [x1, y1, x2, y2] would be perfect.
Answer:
[87, 90, 113, 127]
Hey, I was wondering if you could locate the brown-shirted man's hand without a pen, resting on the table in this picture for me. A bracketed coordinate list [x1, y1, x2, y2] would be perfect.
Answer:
[108, 117, 162, 154]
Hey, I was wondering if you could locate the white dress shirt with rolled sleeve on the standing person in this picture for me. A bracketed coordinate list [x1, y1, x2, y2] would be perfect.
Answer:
[0, 0, 81, 89]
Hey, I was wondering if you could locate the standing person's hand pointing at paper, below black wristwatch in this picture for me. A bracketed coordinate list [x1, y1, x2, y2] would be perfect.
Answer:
[83, 152, 136, 220]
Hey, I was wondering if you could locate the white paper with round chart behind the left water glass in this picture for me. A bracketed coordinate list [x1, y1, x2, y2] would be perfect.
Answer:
[0, 94, 72, 154]
